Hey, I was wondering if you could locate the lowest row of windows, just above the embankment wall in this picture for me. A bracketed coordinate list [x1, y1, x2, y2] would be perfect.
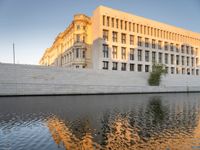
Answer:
[102, 61, 199, 75]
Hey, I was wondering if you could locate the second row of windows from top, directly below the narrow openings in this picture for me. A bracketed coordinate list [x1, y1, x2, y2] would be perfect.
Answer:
[103, 30, 198, 55]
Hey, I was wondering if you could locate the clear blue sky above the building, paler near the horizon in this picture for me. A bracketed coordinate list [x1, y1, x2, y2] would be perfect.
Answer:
[0, 0, 200, 64]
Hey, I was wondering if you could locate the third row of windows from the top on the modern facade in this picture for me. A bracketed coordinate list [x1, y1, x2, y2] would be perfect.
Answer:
[103, 44, 199, 66]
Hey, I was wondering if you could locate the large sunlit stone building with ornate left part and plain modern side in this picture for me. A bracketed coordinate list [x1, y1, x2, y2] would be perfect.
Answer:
[40, 6, 200, 75]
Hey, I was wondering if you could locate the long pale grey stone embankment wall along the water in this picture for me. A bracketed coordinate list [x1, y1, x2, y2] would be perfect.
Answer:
[0, 64, 200, 95]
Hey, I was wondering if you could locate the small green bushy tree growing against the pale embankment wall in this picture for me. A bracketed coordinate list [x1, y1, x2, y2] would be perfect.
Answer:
[148, 64, 166, 86]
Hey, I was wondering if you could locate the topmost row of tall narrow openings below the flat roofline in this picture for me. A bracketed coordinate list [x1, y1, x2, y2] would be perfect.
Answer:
[103, 15, 200, 43]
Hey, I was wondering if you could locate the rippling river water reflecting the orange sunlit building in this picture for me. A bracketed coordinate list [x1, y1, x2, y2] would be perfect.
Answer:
[0, 93, 200, 150]
